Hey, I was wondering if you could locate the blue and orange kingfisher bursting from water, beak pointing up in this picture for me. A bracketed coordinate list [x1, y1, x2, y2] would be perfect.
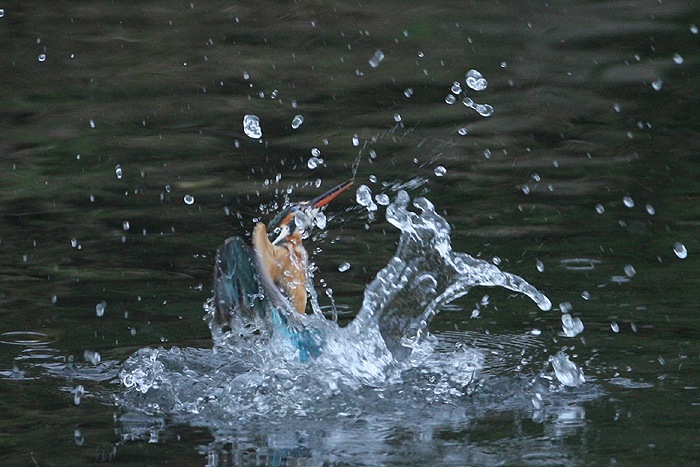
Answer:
[214, 181, 353, 360]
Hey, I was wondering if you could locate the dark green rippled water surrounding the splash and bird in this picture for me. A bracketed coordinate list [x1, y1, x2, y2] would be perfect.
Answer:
[0, 1, 700, 465]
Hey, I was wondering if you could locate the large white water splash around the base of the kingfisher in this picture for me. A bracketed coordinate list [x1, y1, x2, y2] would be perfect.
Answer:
[117, 191, 568, 427]
